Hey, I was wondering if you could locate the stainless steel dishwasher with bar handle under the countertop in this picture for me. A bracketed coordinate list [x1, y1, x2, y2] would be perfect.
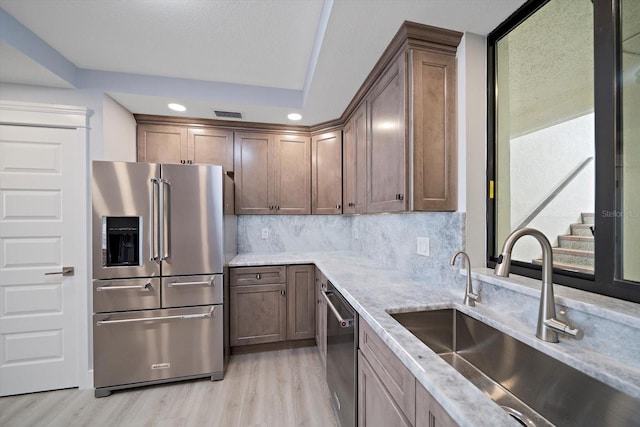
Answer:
[324, 282, 358, 427]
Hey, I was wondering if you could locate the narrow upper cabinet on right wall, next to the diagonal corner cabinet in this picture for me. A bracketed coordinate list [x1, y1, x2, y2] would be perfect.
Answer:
[342, 101, 367, 214]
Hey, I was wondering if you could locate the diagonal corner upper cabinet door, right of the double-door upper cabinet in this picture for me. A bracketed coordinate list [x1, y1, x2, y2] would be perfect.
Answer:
[311, 131, 342, 215]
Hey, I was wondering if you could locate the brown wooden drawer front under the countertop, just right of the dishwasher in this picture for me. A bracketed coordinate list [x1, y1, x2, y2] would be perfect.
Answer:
[359, 322, 416, 425]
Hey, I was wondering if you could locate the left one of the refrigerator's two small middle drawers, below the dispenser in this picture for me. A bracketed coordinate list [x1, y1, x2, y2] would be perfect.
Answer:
[93, 277, 160, 313]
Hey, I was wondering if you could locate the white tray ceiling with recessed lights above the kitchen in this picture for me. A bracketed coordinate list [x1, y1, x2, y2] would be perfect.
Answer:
[0, 0, 525, 125]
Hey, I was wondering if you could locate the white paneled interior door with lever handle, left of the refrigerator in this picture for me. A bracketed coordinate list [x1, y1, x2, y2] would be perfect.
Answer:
[0, 125, 81, 396]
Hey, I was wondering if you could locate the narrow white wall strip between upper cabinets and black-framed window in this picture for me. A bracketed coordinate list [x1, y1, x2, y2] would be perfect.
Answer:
[457, 33, 487, 267]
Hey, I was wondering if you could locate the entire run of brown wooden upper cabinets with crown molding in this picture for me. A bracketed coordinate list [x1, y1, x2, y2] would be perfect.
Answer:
[135, 22, 462, 214]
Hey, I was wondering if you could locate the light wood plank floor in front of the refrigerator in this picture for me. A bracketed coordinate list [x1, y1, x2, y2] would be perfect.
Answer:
[0, 347, 336, 427]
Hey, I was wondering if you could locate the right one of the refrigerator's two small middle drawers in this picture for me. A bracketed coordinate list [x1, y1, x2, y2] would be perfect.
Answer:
[162, 274, 222, 308]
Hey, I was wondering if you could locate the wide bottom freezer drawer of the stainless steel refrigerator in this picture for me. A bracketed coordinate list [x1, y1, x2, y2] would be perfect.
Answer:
[93, 305, 223, 389]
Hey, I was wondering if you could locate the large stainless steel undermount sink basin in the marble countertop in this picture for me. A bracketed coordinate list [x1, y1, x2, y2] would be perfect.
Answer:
[391, 309, 640, 426]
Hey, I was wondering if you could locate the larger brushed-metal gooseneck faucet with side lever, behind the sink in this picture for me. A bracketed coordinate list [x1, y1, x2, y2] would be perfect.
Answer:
[494, 228, 583, 342]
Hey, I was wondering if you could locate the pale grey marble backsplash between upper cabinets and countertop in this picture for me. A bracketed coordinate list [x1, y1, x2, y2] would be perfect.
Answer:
[238, 212, 464, 283]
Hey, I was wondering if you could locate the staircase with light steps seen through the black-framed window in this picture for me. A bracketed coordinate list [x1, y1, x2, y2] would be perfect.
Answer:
[533, 213, 594, 274]
